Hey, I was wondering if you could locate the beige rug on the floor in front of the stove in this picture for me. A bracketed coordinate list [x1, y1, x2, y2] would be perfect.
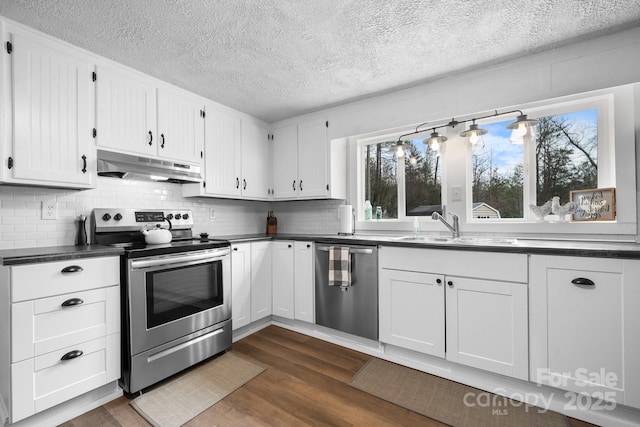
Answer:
[131, 353, 265, 427]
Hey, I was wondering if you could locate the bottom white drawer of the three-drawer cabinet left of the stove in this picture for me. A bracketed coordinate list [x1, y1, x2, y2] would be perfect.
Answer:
[11, 334, 114, 422]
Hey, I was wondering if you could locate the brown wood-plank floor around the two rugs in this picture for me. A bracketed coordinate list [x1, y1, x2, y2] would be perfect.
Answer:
[62, 326, 591, 427]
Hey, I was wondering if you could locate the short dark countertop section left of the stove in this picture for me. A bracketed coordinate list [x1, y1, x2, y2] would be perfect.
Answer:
[0, 245, 124, 265]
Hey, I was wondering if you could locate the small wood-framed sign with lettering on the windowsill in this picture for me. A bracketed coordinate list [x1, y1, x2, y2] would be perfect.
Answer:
[569, 187, 616, 222]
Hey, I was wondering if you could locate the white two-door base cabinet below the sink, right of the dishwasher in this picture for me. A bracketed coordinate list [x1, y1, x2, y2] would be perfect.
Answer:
[379, 247, 529, 380]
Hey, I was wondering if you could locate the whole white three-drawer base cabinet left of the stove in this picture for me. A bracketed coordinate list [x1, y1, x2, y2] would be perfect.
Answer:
[1, 256, 120, 423]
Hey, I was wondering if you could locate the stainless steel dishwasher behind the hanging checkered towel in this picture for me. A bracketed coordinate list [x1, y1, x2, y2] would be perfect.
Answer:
[315, 244, 378, 340]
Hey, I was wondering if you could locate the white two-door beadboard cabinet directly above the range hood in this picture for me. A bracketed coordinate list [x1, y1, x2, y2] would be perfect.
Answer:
[96, 65, 204, 164]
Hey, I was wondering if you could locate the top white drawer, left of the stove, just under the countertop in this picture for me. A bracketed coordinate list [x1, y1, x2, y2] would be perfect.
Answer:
[11, 256, 120, 302]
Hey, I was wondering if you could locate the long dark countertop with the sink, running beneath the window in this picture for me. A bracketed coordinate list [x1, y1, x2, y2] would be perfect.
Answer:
[221, 233, 640, 259]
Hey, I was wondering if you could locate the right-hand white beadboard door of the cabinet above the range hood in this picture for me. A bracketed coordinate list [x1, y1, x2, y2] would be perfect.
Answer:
[157, 87, 204, 164]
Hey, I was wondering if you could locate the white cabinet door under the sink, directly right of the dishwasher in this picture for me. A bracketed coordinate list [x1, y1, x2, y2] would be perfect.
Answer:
[379, 269, 445, 357]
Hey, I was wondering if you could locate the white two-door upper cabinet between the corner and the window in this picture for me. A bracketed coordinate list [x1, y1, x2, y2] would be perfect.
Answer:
[273, 119, 346, 200]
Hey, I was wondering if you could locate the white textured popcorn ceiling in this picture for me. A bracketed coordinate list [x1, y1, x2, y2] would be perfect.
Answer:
[0, 0, 640, 122]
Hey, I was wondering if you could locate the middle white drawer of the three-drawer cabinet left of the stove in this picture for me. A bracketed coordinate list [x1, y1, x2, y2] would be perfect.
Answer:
[11, 286, 120, 363]
